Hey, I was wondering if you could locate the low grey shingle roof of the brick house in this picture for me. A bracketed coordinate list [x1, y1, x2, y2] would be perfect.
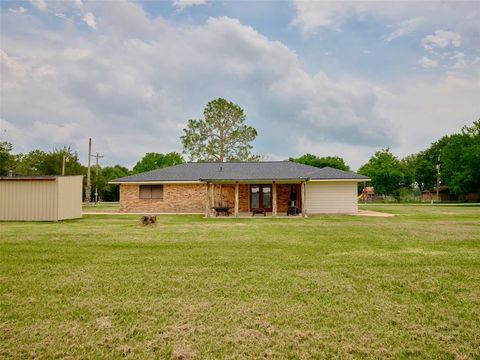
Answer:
[111, 161, 368, 183]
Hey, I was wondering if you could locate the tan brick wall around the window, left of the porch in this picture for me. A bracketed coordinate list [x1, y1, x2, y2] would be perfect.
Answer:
[120, 184, 207, 213]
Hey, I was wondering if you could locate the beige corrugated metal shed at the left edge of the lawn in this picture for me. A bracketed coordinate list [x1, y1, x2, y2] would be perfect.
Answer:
[0, 176, 83, 221]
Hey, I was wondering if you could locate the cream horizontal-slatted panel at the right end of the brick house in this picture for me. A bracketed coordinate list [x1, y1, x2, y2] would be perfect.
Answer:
[306, 181, 358, 214]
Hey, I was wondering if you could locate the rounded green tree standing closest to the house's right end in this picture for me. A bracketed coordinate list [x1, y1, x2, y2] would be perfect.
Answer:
[358, 149, 408, 195]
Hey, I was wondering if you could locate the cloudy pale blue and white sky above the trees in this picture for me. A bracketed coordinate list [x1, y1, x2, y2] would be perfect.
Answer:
[0, 0, 480, 170]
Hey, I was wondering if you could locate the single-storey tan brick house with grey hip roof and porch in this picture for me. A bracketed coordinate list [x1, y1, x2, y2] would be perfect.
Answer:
[110, 161, 369, 216]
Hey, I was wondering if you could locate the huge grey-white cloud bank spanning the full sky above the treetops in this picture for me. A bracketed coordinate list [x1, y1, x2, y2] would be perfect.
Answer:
[0, 3, 478, 167]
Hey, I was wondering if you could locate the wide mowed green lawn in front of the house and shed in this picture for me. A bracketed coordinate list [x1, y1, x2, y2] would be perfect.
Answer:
[0, 205, 480, 359]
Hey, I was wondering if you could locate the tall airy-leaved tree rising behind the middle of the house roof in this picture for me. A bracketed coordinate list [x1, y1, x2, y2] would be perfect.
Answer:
[181, 98, 259, 161]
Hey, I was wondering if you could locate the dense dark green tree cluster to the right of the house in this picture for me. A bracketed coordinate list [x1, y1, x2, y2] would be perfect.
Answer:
[358, 119, 480, 198]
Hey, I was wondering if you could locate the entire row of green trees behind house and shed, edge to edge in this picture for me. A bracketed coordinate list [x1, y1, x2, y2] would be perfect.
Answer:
[0, 98, 480, 201]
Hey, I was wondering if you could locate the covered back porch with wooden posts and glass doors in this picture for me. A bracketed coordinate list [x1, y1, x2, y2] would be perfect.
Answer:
[205, 181, 306, 217]
